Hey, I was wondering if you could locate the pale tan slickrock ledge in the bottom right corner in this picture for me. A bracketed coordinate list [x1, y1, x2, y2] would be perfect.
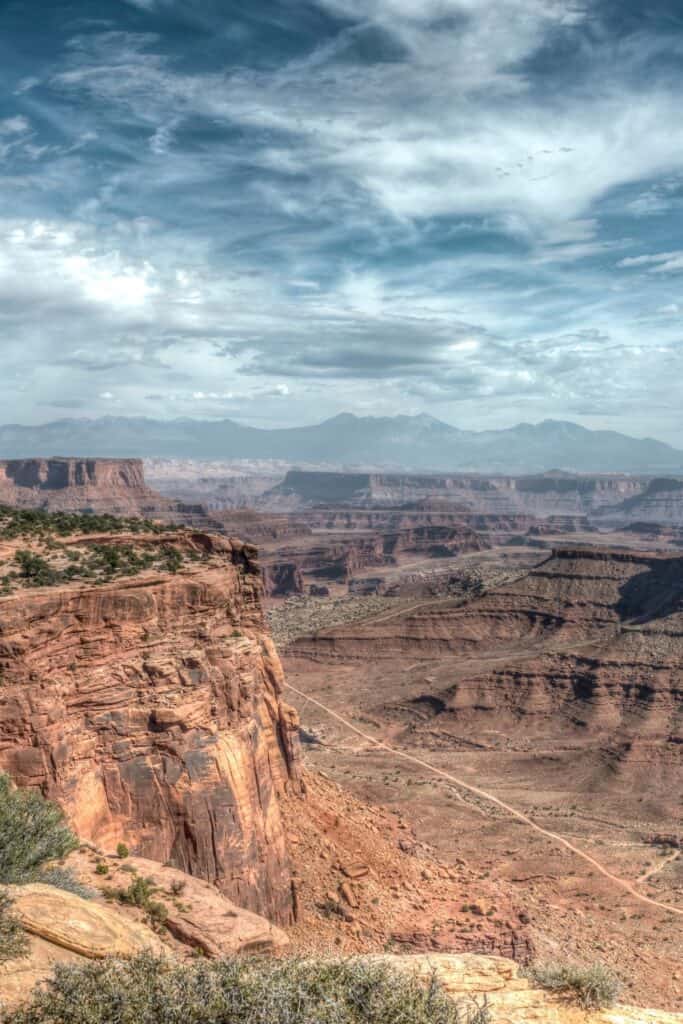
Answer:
[378, 953, 683, 1024]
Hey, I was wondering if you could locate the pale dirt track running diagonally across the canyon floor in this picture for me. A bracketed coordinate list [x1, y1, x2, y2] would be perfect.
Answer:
[285, 683, 683, 918]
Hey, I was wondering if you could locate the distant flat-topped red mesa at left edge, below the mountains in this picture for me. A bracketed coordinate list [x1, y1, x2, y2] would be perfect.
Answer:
[0, 459, 173, 515]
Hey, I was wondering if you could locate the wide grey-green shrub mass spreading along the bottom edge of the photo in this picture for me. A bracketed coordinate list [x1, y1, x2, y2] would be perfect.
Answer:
[6, 955, 497, 1024]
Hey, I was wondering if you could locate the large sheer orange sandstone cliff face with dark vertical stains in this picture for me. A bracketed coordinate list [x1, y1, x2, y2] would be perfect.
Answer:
[0, 535, 297, 923]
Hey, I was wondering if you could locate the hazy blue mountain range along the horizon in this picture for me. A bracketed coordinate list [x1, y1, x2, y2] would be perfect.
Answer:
[0, 413, 683, 475]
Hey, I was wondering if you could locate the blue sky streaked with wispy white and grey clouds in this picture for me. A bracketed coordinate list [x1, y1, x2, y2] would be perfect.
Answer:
[0, 0, 683, 446]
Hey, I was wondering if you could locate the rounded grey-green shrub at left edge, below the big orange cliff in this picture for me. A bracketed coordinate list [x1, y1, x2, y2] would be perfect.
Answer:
[0, 774, 78, 884]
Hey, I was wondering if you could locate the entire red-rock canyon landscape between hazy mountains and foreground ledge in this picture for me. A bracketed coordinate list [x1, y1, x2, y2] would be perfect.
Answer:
[0, 460, 683, 1008]
